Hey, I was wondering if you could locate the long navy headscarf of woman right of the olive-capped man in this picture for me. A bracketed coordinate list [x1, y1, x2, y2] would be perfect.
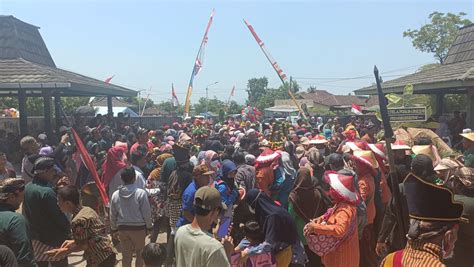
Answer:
[245, 189, 297, 248]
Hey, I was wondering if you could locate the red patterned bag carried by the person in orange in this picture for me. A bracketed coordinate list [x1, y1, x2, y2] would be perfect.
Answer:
[304, 207, 357, 257]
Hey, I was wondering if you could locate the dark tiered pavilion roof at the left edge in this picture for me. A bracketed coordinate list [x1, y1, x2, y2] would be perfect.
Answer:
[0, 16, 137, 96]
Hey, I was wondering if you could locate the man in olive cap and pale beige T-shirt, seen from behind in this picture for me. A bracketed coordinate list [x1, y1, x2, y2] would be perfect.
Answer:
[175, 186, 234, 267]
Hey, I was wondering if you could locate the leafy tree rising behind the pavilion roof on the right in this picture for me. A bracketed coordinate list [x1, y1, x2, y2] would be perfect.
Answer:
[403, 12, 472, 63]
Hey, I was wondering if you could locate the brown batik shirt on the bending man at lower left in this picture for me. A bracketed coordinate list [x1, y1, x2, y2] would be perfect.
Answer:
[71, 206, 115, 266]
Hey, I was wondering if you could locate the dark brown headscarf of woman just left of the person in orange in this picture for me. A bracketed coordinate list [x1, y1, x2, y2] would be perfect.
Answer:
[289, 167, 328, 222]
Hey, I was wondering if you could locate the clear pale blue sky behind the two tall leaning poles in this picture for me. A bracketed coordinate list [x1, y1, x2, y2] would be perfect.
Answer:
[0, 0, 474, 103]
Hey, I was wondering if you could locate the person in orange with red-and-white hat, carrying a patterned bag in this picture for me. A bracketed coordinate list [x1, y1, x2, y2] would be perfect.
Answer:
[303, 171, 360, 267]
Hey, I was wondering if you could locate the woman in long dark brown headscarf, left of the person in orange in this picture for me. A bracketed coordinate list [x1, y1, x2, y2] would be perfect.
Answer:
[288, 167, 331, 267]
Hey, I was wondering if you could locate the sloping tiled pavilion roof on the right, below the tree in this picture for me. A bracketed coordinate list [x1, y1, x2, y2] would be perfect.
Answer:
[354, 24, 474, 95]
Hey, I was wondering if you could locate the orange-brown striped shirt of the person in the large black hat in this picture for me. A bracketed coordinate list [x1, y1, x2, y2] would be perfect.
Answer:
[380, 241, 446, 267]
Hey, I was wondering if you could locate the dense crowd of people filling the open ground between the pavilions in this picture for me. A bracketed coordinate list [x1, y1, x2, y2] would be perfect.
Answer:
[0, 112, 474, 267]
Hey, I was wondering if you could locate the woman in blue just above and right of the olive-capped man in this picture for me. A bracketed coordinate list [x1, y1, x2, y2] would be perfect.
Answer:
[214, 159, 239, 218]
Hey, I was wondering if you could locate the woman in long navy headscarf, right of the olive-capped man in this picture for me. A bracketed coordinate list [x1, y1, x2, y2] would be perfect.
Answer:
[245, 189, 298, 267]
